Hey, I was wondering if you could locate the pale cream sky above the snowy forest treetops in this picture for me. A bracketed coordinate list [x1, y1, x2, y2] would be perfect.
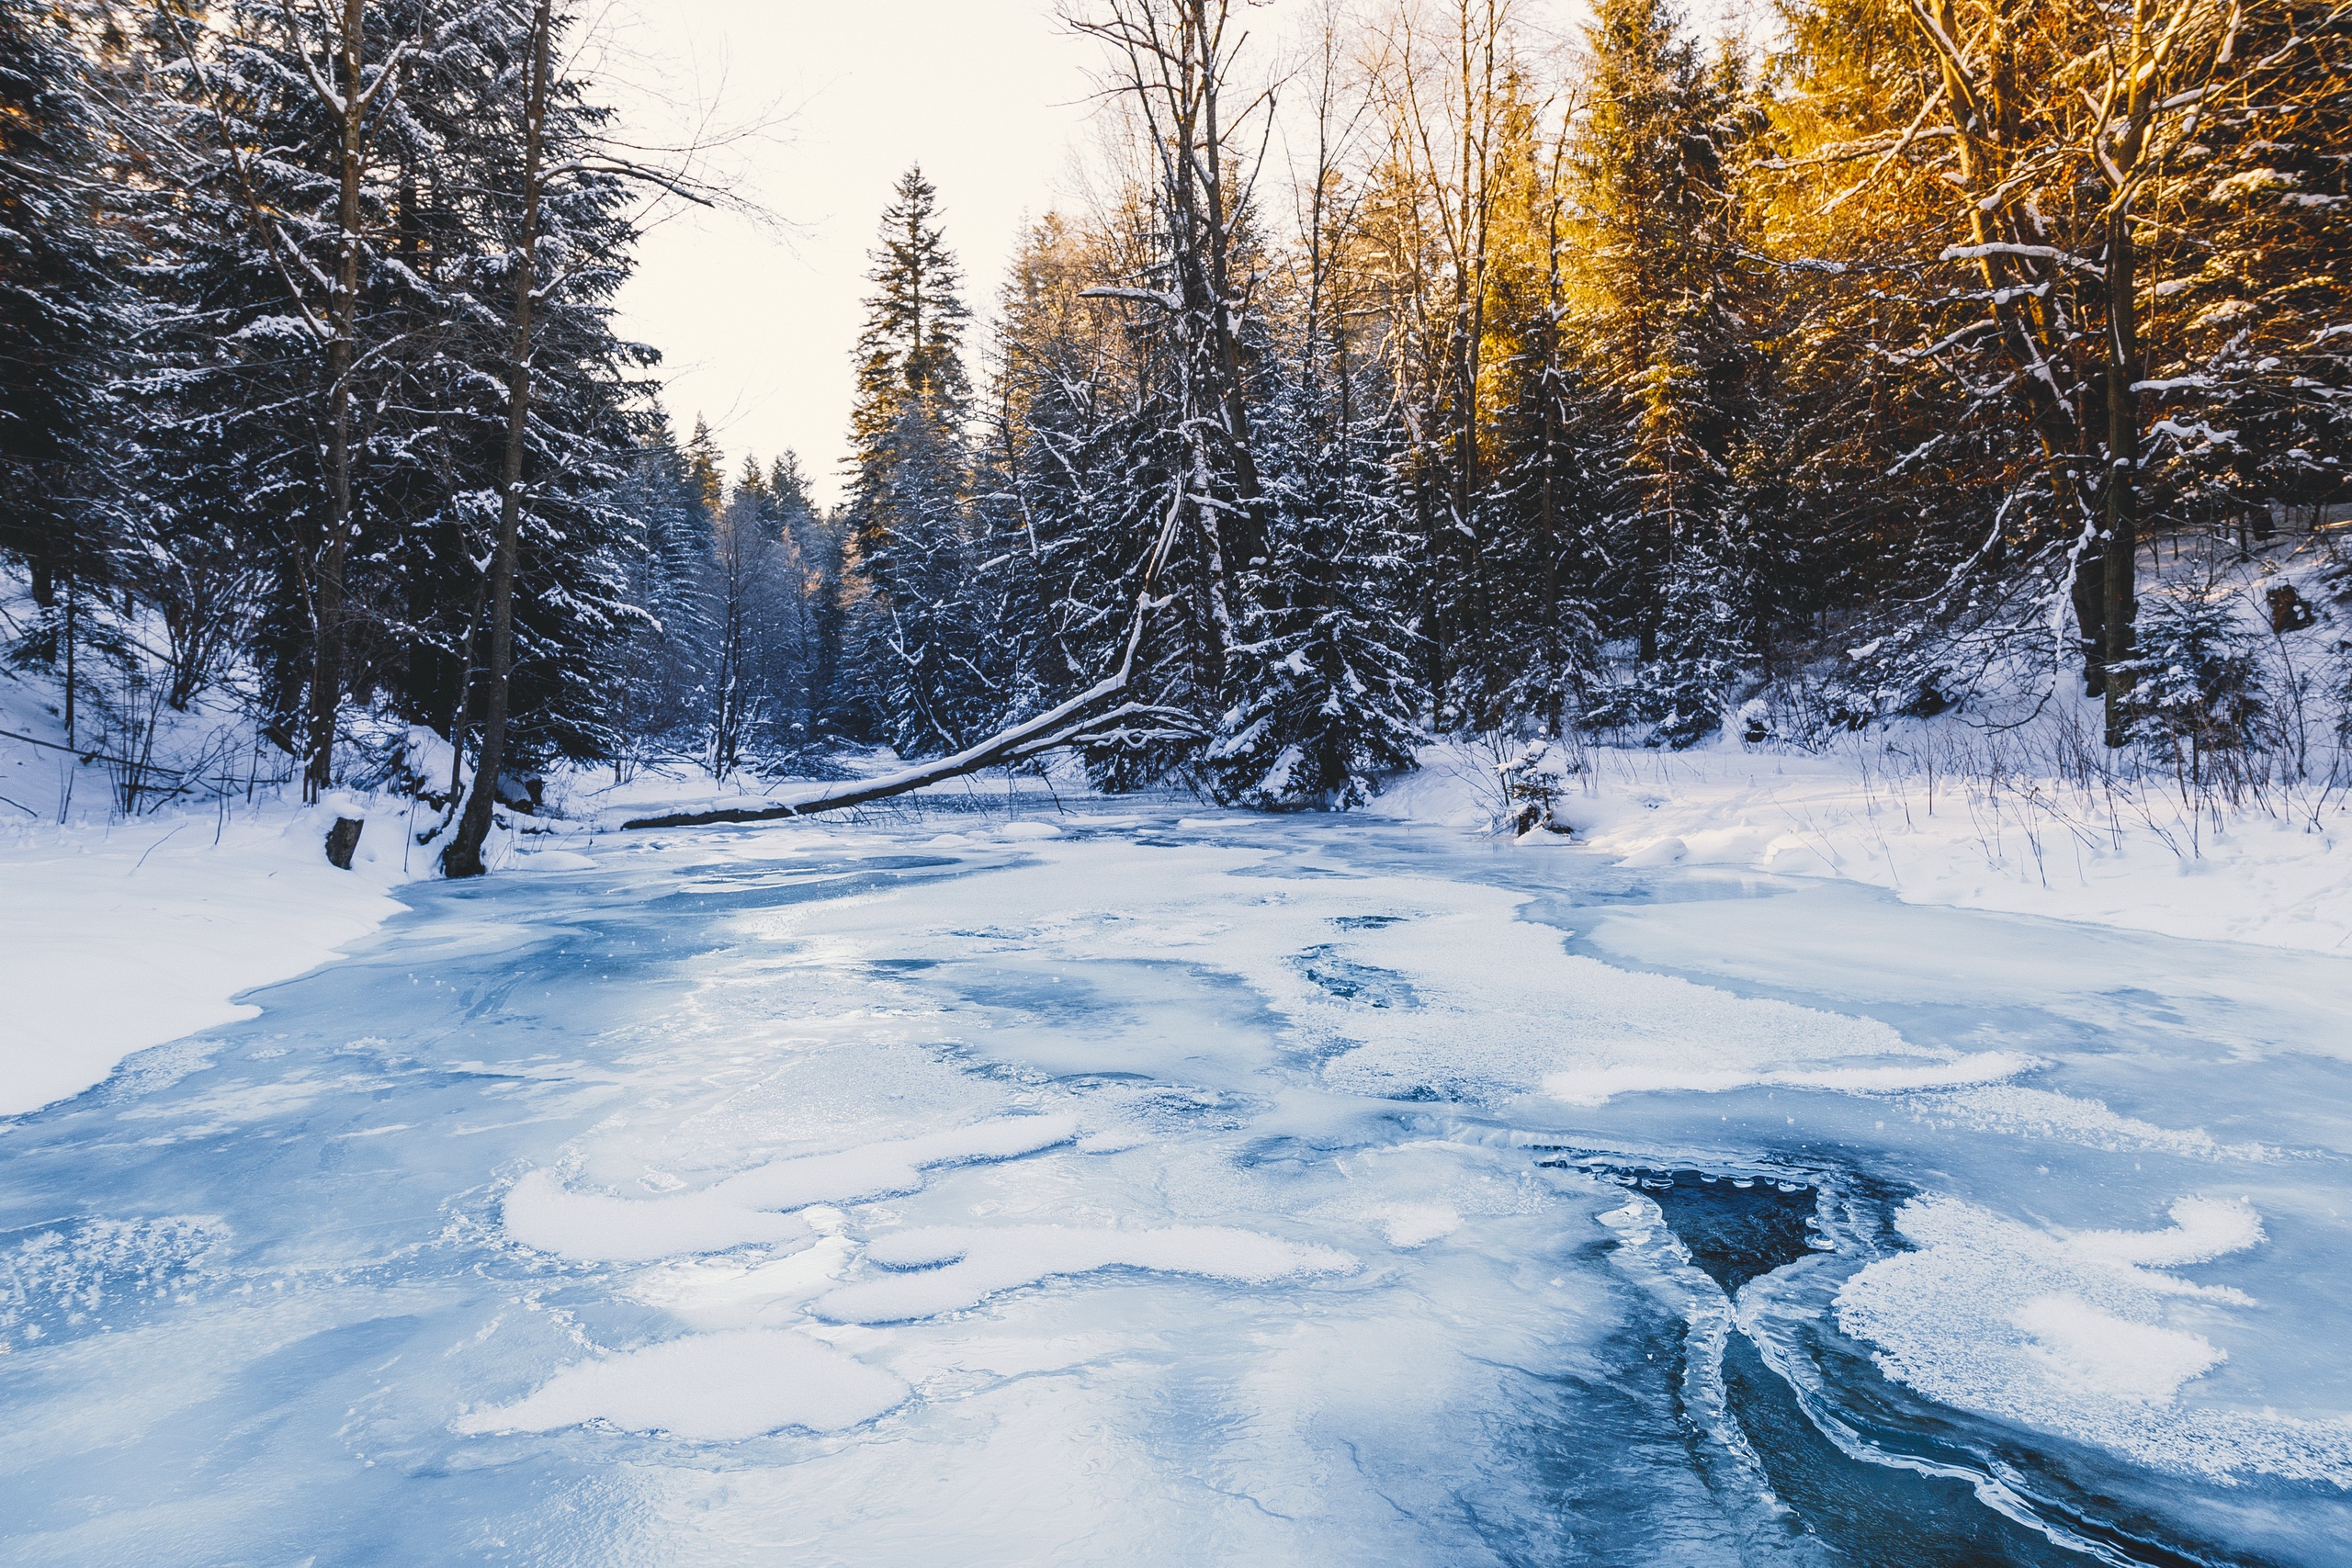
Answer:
[597, 0, 1743, 503]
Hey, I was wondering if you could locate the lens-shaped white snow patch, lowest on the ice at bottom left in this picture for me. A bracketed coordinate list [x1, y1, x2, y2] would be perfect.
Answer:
[457, 1328, 908, 1443]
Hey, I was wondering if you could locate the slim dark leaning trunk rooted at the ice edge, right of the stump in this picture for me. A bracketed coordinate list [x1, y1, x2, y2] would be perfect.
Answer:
[442, 0, 555, 877]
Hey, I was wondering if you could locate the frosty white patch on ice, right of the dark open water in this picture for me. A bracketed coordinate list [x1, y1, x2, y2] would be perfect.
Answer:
[1837, 1197, 2352, 1488]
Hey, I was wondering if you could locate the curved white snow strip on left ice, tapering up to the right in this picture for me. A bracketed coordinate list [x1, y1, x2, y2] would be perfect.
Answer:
[503, 1117, 1077, 1262]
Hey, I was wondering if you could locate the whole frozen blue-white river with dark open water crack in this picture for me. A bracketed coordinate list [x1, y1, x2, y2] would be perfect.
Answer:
[0, 802, 2352, 1568]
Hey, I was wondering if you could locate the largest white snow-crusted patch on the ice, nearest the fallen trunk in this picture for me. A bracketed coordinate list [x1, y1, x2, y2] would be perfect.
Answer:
[729, 831, 2032, 1105]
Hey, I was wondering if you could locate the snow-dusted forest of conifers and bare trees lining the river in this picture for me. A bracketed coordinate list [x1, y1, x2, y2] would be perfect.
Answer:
[0, 0, 2352, 874]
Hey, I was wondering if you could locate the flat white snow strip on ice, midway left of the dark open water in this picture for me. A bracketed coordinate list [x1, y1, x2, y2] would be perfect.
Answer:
[816, 1224, 1357, 1324]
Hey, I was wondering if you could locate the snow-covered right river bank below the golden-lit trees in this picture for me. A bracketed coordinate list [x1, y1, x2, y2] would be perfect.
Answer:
[1371, 731, 2352, 952]
